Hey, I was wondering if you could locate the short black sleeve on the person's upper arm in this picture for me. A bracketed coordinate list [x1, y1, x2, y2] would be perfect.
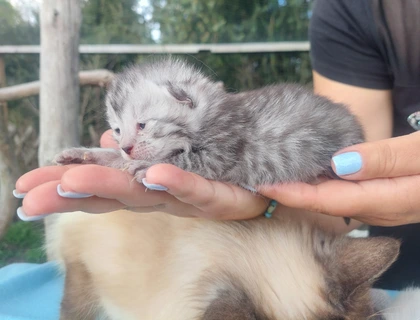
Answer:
[309, 0, 393, 89]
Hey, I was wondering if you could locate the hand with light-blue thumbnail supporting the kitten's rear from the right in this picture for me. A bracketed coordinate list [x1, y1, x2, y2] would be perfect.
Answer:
[258, 132, 420, 226]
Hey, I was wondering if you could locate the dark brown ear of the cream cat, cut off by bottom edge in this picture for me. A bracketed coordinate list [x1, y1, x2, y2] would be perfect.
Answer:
[201, 289, 262, 320]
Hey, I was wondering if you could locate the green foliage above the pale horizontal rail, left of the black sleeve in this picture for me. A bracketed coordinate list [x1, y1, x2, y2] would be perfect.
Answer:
[152, 0, 312, 43]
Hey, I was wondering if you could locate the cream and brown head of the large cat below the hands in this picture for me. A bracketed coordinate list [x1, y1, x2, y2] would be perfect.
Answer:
[190, 219, 400, 320]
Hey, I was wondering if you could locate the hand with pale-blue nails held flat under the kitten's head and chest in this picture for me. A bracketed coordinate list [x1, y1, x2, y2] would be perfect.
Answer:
[16, 131, 268, 221]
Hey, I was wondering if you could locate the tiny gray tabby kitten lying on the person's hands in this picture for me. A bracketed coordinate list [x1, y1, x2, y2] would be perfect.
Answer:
[55, 58, 364, 186]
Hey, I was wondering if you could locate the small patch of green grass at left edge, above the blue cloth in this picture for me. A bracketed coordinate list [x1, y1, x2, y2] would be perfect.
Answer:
[0, 221, 46, 268]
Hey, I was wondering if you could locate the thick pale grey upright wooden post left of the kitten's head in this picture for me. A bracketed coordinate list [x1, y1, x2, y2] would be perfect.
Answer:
[38, 0, 81, 259]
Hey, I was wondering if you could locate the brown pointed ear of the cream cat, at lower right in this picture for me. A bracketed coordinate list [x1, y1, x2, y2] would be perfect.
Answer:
[332, 237, 401, 294]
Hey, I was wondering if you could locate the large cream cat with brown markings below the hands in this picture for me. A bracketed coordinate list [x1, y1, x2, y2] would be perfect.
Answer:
[49, 208, 399, 320]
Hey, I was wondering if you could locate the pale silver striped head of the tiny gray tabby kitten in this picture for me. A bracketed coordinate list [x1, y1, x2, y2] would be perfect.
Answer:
[106, 58, 224, 160]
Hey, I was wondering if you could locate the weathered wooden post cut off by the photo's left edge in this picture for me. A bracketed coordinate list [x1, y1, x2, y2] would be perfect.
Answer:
[0, 55, 20, 238]
